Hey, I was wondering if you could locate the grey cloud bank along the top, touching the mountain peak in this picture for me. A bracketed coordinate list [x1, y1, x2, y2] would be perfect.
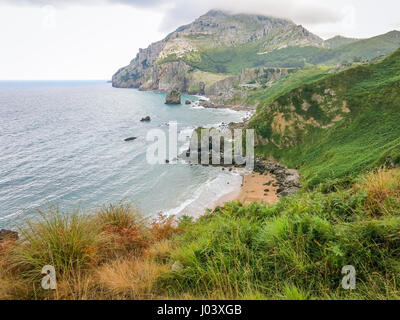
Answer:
[0, 0, 346, 32]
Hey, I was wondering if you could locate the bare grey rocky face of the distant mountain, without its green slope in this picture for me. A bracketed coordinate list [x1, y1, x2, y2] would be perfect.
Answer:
[112, 10, 323, 96]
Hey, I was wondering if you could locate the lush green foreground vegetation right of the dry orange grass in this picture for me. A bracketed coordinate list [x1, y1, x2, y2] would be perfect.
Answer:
[160, 170, 400, 299]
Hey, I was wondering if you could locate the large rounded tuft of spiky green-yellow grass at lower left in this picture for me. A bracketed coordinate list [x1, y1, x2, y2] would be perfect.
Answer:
[14, 209, 105, 277]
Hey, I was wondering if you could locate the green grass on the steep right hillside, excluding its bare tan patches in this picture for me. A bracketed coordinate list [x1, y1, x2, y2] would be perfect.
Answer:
[251, 51, 400, 186]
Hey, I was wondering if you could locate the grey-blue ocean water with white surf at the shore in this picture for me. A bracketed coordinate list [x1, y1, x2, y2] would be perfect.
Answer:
[0, 81, 245, 228]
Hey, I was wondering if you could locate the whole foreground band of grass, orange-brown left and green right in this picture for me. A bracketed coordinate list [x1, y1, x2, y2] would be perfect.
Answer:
[0, 168, 400, 300]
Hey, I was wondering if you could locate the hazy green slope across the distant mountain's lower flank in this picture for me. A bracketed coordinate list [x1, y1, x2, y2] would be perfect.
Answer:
[164, 31, 400, 74]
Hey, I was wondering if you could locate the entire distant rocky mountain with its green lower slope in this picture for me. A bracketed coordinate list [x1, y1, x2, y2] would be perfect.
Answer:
[112, 10, 400, 99]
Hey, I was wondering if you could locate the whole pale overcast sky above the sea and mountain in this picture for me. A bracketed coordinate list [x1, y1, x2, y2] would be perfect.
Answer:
[0, 0, 400, 80]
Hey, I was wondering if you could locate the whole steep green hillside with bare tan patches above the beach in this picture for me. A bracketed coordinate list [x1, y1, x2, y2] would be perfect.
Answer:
[250, 50, 400, 187]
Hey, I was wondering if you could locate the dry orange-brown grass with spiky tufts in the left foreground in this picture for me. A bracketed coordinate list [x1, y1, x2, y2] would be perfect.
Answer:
[0, 204, 179, 299]
